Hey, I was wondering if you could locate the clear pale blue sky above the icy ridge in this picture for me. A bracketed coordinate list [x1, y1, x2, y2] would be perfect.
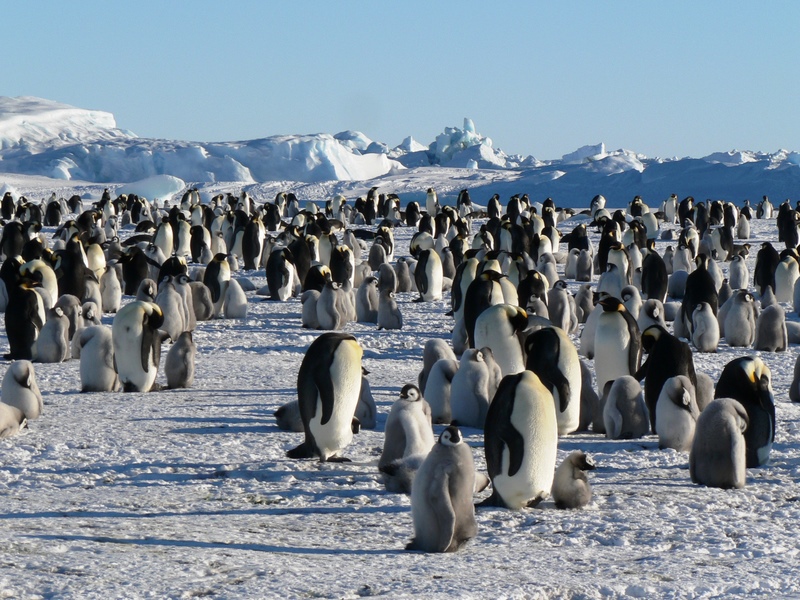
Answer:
[6, 0, 800, 159]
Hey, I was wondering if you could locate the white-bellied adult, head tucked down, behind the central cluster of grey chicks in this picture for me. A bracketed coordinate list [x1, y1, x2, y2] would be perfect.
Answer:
[475, 304, 528, 376]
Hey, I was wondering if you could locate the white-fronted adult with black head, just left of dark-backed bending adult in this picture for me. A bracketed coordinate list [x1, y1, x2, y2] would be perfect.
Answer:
[594, 296, 642, 390]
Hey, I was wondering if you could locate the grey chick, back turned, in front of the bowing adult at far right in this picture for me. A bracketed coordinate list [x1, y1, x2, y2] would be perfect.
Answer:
[689, 398, 749, 489]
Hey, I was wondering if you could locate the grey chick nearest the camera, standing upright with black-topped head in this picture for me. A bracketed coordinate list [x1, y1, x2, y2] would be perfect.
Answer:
[406, 426, 478, 552]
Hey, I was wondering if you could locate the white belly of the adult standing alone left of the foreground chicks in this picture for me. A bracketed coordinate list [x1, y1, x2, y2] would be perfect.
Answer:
[308, 344, 361, 460]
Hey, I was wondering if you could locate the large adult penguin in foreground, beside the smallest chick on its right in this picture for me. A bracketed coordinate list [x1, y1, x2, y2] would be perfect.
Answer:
[480, 370, 558, 510]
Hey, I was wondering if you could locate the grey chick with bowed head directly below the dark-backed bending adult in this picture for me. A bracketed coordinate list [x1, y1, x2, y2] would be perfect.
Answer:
[656, 375, 700, 452]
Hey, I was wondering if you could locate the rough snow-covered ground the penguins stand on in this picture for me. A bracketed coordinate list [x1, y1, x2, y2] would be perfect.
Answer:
[0, 176, 800, 598]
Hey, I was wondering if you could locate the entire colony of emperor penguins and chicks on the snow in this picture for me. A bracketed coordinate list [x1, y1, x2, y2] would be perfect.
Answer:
[0, 188, 800, 552]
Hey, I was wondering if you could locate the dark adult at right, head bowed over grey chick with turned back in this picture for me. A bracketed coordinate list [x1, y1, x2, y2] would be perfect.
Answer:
[714, 356, 775, 468]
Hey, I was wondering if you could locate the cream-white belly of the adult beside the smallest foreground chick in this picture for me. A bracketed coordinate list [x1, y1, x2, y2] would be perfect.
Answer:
[492, 386, 558, 510]
